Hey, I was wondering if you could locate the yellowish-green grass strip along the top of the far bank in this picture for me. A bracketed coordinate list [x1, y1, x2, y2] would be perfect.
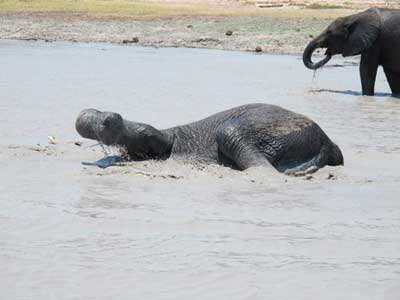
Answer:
[0, 0, 354, 18]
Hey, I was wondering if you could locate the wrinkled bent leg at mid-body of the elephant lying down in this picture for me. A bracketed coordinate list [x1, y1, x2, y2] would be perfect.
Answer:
[217, 124, 271, 170]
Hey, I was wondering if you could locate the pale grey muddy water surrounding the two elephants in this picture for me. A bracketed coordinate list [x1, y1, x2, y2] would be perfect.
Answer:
[0, 41, 400, 300]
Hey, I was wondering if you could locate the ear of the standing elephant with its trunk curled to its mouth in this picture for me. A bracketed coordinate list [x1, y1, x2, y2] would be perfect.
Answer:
[343, 9, 381, 57]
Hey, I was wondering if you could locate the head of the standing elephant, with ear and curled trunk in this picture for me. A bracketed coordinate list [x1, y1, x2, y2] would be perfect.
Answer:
[303, 8, 381, 70]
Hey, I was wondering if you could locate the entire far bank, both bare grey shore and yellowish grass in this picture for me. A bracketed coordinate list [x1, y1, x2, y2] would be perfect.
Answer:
[0, 0, 354, 54]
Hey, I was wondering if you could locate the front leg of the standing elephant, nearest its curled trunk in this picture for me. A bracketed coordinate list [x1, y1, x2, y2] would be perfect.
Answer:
[360, 46, 379, 96]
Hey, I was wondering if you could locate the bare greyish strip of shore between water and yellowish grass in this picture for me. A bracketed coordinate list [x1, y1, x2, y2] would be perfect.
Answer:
[0, 9, 352, 54]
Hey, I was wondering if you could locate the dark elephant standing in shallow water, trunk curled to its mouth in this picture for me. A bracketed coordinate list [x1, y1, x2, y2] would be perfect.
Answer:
[303, 8, 400, 96]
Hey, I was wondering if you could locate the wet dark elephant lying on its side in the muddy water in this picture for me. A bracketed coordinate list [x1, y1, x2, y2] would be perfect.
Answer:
[76, 104, 343, 174]
